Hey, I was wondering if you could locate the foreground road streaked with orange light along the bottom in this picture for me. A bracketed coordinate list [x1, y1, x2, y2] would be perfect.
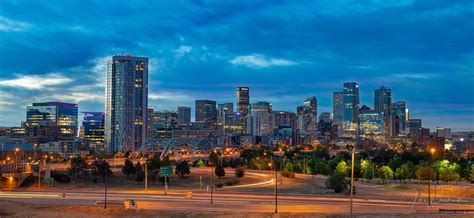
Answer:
[0, 191, 474, 214]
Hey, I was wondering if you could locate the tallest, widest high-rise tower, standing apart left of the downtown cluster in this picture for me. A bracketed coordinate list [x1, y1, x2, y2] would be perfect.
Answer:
[105, 55, 148, 152]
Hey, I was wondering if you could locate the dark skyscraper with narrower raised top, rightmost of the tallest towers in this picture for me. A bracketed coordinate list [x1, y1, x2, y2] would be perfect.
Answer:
[374, 86, 393, 138]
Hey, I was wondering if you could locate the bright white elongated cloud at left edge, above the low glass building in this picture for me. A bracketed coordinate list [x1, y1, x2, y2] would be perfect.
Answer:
[0, 73, 72, 89]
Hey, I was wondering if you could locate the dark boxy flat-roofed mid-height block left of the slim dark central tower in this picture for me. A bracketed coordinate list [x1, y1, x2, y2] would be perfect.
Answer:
[196, 100, 217, 128]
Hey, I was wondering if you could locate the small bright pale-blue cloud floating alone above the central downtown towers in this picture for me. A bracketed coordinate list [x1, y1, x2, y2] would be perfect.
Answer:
[230, 54, 298, 68]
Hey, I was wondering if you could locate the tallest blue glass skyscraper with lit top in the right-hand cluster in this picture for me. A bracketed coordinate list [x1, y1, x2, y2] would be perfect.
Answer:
[343, 82, 359, 138]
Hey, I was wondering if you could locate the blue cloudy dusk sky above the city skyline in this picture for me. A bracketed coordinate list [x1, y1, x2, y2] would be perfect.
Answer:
[0, 0, 474, 131]
